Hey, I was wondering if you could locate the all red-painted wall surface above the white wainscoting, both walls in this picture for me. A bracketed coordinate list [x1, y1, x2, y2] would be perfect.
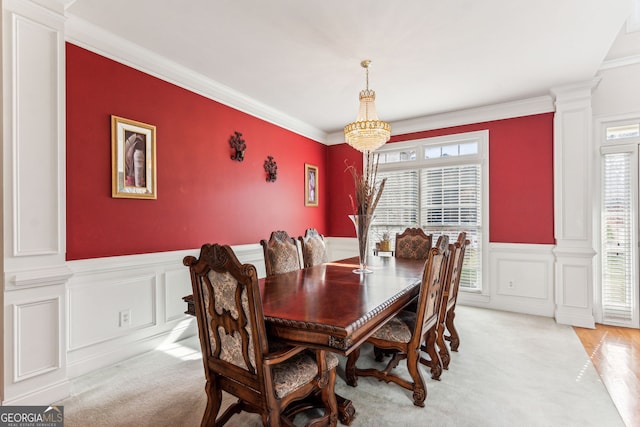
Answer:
[66, 44, 554, 260]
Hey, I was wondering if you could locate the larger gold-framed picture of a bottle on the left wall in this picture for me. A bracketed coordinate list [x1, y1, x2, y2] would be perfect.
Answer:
[111, 116, 157, 199]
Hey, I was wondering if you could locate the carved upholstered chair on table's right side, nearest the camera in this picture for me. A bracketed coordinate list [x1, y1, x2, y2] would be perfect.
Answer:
[345, 236, 449, 407]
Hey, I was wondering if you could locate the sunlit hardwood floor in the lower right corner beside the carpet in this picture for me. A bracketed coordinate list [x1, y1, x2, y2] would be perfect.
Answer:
[573, 324, 640, 427]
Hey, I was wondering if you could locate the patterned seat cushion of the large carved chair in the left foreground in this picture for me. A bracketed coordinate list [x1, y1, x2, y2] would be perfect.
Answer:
[272, 351, 338, 399]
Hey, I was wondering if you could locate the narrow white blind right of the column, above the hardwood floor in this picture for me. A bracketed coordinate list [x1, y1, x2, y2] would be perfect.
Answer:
[601, 152, 634, 321]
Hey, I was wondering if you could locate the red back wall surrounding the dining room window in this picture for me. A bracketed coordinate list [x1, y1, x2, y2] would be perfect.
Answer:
[327, 113, 555, 244]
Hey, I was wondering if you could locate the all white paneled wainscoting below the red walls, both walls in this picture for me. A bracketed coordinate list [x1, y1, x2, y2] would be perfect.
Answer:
[63, 241, 554, 378]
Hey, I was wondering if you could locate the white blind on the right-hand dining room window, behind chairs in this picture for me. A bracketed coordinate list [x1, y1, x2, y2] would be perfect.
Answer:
[421, 164, 482, 290]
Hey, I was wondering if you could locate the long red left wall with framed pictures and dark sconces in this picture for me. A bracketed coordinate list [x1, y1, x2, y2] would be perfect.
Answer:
[66, 44, 329, 260]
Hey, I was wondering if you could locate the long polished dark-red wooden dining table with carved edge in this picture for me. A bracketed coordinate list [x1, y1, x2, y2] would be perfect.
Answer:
[184, 256, 425, 425]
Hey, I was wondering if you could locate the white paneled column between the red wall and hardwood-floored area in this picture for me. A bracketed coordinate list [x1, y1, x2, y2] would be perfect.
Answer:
[551, 79, 599, 328]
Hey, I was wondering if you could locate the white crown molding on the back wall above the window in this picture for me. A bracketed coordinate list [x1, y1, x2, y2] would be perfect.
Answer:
[327, 95, 555, 145]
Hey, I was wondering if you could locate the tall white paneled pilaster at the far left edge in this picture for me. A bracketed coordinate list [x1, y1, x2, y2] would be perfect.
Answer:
[0, 0, 71, 405]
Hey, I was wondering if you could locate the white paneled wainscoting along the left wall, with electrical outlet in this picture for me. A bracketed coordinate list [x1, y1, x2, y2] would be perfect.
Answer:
[66, 244, 265, 378]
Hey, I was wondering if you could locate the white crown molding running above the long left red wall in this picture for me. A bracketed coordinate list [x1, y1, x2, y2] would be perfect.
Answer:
[65, 14, 327, 142]
